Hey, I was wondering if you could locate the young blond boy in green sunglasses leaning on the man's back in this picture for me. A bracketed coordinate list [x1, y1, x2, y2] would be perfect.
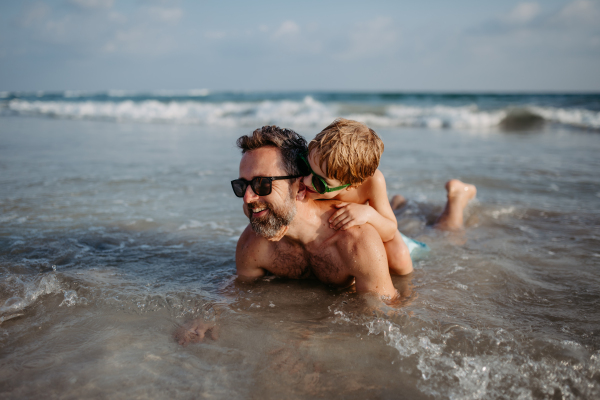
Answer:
[303, 118, 413, 275]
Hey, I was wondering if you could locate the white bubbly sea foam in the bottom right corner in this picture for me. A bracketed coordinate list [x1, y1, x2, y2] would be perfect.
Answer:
[365, 319, 600, 399]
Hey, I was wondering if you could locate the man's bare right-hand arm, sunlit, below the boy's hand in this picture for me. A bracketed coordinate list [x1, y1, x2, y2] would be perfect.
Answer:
[337, 225, 398, 299]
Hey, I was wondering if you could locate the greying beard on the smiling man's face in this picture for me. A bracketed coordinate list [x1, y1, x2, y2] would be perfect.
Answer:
[247, 190, 296, 239]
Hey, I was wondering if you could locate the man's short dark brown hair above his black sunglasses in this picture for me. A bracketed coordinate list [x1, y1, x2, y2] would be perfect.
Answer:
[237, 125, 308, 175]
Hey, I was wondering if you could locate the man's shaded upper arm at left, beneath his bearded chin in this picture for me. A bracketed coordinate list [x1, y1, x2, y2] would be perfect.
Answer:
[235, 225, 269, 281]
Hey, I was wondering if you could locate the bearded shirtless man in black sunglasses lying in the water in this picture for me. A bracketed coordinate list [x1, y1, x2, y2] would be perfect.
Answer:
[232, 126, 396, 298]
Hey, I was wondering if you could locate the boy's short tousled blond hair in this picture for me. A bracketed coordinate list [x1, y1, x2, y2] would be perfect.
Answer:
[308, 118, 383, 187]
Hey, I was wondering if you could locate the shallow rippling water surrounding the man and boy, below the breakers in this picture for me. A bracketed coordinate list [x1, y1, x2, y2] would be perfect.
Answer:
[0, 116, 600, 399]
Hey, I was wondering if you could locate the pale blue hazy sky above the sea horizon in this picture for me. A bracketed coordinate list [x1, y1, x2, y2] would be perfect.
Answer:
[0, 0, 600, 92]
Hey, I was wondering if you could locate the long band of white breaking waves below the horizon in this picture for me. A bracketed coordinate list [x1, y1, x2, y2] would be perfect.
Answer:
[0, 92, 600, 130]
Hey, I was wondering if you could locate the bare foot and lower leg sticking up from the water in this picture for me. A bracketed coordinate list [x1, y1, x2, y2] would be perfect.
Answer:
[434, 179, 477, 231]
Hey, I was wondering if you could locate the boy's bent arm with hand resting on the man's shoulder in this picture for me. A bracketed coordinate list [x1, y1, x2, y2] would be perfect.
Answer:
[329, 170, 398, 243]
